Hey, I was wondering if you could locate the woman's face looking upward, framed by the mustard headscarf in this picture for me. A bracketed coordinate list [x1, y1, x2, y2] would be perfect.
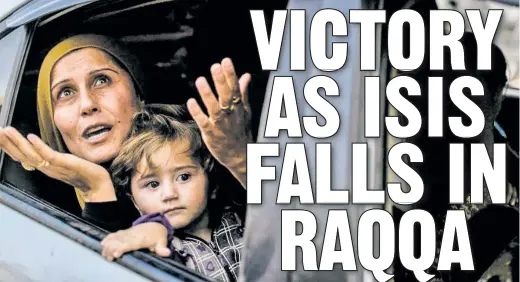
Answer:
[51, 48, 137, 163]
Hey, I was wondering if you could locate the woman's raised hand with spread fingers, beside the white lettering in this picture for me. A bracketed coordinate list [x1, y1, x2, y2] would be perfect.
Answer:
[188, 58, 253, 187]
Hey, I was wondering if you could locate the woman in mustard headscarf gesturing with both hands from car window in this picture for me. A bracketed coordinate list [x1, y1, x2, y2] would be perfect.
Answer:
[0, 34, 252, 230]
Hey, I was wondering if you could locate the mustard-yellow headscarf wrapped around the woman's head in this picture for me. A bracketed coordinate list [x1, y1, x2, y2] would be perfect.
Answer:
[37, 34, 144, 208]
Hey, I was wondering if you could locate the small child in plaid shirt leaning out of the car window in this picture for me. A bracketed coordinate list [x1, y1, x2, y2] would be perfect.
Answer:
[102, 105, 244, 281]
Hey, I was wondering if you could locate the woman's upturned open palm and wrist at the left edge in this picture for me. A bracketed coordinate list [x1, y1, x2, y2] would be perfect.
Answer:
[0, 127, 117, 202]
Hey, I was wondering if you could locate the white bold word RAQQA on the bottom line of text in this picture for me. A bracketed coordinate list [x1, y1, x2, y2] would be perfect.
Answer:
[282, 209, 474, 282]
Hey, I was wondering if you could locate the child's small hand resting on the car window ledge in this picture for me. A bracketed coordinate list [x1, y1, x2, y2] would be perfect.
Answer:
[101, 222, 171, 261]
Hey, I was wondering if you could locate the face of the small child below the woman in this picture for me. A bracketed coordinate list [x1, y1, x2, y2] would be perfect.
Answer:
[131, 140, 208, 229]
